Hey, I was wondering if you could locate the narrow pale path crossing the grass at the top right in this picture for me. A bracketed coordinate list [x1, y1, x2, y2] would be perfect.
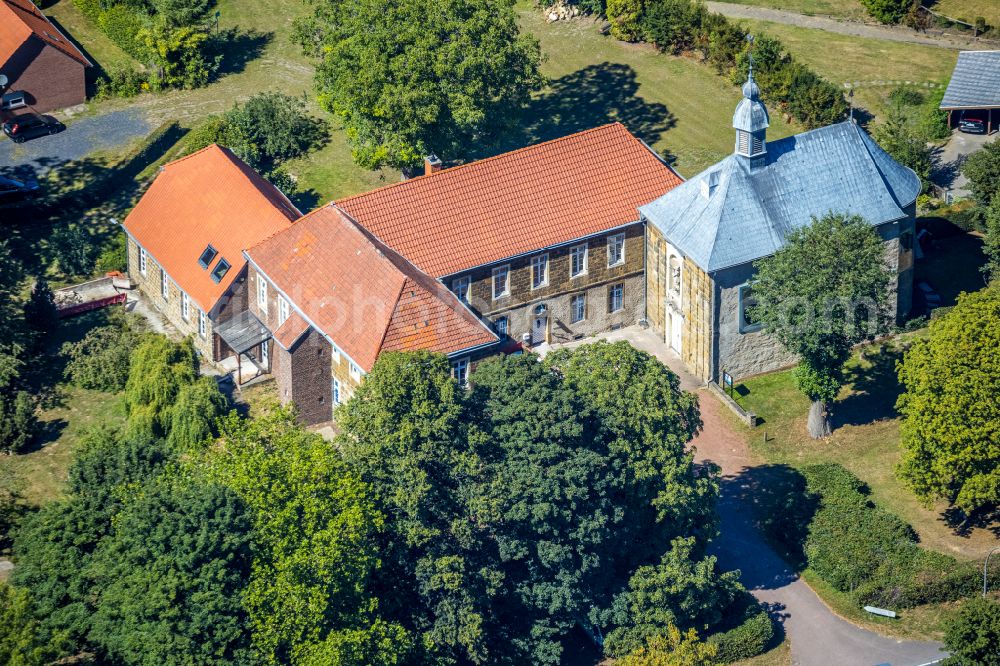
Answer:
[705, 2, 991, 49]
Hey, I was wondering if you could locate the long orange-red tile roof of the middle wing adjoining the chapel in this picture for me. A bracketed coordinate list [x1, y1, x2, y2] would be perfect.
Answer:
[336, 123, 682, 277]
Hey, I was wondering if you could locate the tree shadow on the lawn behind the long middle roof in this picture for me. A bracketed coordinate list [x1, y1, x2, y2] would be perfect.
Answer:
[471, 62, 677, 162]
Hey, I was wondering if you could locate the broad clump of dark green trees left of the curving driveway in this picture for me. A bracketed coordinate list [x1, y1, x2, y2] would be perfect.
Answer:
[338, 343, 723, 664]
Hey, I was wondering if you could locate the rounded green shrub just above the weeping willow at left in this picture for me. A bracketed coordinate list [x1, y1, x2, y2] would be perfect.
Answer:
[62, 309, 146, 391]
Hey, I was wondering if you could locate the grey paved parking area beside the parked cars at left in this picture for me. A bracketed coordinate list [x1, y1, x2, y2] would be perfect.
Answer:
[0, 109, 151, 169]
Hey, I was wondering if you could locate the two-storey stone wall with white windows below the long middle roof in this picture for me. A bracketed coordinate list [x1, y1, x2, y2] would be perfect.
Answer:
[452, 223, 644, 342]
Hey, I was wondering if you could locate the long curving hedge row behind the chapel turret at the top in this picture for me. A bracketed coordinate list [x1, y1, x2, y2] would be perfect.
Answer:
[580, 0, 848, 129]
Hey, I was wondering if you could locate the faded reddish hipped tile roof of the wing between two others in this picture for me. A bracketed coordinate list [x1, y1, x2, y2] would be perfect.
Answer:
[246, 205, 497, 371]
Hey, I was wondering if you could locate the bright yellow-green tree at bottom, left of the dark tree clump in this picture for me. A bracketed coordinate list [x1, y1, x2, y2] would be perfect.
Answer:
[207, 410, 411, 666]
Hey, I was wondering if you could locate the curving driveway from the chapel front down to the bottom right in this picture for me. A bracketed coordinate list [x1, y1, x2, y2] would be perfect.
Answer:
[541, 327, 944, 666]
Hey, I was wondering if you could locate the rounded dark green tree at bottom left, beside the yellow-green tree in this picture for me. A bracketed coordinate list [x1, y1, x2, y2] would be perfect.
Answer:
[89, 480, 250, 666]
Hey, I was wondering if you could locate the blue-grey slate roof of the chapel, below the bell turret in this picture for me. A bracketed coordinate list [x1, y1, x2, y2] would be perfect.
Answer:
[639, 122, 920, 272]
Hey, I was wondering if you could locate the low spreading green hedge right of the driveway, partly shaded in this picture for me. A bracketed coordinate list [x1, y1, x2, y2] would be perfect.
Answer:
[758, 463, 1000, 608]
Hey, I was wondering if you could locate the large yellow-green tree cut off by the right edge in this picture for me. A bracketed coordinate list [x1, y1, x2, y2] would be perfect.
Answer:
[897, 287, 1000, 512]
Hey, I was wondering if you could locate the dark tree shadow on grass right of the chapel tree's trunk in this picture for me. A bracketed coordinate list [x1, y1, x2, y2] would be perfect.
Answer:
[831, 344, 903, 430]
